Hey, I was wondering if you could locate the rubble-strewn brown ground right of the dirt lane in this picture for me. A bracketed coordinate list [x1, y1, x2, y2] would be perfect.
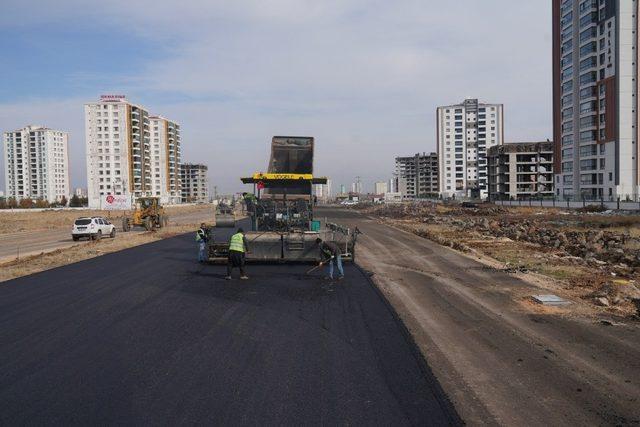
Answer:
[362, 203, 640, 318]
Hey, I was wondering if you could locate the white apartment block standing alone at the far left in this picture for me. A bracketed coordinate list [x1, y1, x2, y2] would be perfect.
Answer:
[3, 126, 70, 203]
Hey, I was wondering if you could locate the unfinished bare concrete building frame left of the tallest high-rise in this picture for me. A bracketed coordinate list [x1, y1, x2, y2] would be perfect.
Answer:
[487, 141, 554, 200]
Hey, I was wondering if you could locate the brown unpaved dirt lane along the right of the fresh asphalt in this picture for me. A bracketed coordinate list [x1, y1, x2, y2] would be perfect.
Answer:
[318, 209, 640, 426]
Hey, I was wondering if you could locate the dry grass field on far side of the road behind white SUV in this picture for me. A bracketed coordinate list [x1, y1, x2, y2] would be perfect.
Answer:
[0, 205, 212, 234]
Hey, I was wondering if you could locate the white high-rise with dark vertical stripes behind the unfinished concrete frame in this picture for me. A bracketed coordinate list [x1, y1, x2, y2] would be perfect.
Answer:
[436, 99, 504, 198]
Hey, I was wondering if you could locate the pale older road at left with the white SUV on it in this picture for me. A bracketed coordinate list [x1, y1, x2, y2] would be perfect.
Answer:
[0, 208, 213, 261]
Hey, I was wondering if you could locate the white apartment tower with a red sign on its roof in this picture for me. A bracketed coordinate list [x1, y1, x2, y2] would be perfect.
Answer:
[84, 95, 153, 209]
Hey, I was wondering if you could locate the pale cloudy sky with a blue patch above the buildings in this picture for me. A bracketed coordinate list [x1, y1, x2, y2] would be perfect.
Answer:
[0, 0, 552, 193]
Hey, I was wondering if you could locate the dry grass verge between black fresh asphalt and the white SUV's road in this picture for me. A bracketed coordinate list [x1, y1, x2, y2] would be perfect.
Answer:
[0, 224, 193, 282]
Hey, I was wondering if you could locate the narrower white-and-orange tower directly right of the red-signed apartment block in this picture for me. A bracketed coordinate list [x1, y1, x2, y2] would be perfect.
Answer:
[149, 116, 182, 204]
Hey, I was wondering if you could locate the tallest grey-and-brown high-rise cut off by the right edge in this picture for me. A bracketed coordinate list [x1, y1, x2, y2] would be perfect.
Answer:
[553, 0, 640, 199]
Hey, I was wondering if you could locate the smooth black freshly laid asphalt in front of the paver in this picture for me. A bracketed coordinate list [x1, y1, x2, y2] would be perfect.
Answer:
[0, 224, 459, 425]
